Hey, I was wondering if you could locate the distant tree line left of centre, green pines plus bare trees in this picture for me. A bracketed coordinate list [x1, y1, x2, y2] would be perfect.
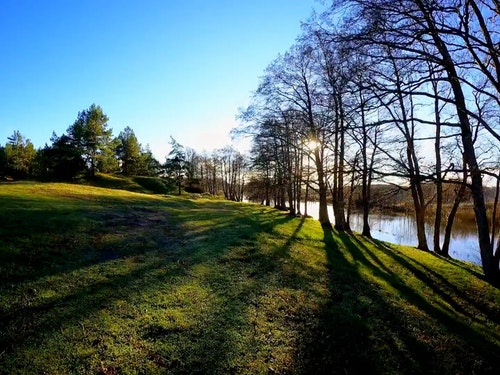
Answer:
[0, 104, 247, 201]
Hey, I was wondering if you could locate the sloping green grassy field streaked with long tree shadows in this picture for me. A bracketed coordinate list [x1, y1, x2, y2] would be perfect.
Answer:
[0, 183, 500, 374]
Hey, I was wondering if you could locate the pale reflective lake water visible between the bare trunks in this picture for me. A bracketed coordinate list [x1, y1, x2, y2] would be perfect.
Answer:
[301, 202, 481, 265]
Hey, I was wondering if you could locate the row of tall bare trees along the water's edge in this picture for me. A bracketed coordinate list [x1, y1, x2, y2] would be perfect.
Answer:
[240, 0, 500, 280]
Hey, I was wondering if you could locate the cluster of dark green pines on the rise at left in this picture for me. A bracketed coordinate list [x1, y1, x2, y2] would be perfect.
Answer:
[0, 104, 161, 180]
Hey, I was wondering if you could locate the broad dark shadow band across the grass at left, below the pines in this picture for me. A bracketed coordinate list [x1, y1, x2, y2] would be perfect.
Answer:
[0, 194, 274, 286]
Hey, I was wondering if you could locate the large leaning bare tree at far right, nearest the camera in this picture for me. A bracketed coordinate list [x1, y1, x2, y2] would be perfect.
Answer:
[326, 0, 500, 281]
